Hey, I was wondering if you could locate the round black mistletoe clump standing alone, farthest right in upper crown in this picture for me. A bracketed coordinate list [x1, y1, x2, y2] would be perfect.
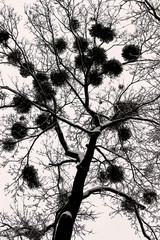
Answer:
[122, 44, 141, 61]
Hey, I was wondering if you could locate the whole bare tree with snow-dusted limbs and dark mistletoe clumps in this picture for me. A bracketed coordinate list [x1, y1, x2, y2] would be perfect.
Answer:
[0, 0, 160, 240]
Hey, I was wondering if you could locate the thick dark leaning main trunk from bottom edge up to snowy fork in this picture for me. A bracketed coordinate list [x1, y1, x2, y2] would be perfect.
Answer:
[52, 132, 99, 240]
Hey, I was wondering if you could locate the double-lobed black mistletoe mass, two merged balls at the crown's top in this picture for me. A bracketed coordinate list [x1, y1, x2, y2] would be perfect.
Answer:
[89, 23, 116, 43]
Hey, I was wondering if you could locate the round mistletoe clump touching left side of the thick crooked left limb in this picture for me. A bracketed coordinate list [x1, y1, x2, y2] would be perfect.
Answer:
[35, 113, 53, 130]
